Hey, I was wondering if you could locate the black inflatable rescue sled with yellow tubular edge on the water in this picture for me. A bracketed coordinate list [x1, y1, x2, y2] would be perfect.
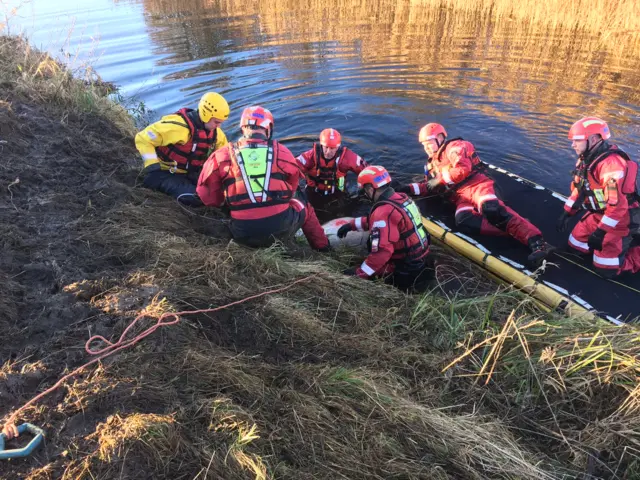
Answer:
[416, 165, 640, 323]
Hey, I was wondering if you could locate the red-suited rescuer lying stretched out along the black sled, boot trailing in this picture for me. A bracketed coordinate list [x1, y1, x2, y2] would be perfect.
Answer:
[397, 123, 554, 266]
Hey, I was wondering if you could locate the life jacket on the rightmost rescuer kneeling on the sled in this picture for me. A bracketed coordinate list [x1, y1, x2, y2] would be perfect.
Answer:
[572, 145, 640, 212]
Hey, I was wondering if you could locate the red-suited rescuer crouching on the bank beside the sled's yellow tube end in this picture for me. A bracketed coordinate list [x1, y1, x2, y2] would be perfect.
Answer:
[337, 166, 430, 290]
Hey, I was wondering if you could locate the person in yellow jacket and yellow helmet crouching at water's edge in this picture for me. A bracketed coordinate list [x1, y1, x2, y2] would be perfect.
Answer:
[135, 92, 229, 204]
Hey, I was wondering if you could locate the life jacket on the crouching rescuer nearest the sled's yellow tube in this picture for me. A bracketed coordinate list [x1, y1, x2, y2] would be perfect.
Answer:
[369, 197, 431, 261]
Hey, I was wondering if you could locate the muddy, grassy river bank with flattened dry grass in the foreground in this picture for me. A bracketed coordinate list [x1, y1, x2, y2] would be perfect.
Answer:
[0, 37, 640, 480]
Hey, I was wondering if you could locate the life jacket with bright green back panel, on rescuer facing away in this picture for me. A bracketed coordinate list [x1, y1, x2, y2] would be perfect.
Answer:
[222, 141, 293, 211]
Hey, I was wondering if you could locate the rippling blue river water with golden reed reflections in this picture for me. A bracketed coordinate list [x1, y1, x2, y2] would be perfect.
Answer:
[5, 0, 640, 193]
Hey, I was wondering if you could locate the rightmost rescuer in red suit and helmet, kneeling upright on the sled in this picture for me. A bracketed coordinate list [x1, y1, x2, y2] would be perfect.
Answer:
[557, 117, 640, 277]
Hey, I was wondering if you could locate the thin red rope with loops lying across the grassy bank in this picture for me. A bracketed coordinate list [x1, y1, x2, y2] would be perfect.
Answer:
[3, 275, 314, 432]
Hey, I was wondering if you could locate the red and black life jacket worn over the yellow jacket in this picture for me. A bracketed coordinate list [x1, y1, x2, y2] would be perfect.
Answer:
[156, 108, 218, 173]
